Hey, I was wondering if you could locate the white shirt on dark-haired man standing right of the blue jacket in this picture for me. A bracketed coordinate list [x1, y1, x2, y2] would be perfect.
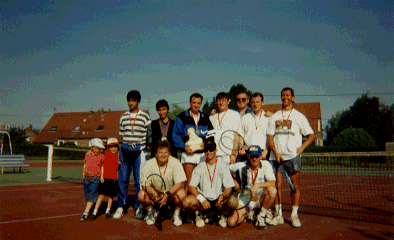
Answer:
[207, 109, 241, 158]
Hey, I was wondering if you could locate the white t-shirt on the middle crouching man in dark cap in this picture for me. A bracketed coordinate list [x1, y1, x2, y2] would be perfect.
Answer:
[189, 161, 235, 201]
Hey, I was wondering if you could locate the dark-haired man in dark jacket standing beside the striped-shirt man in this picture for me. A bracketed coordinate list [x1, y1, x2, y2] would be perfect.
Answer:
[152, 99, 177, 158]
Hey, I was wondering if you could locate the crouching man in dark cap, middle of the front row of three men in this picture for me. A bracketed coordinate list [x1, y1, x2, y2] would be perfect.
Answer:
[182, 137, 234, 228]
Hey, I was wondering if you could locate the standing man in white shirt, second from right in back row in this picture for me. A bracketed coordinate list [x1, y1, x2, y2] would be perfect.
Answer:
[238, 92, 269, 160]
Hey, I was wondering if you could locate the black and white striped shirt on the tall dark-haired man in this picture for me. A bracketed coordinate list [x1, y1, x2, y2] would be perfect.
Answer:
[119, 110, 151, 145]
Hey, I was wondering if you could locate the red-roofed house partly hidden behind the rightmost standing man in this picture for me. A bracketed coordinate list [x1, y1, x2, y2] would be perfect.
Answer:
[263, 102, 323, 146]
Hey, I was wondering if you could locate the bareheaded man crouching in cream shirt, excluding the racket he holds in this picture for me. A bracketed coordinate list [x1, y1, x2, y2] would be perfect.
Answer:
[138, 140, 186, 226]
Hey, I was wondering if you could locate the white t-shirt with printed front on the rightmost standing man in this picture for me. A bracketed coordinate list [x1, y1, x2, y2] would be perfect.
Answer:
[267, 108, 314, 160]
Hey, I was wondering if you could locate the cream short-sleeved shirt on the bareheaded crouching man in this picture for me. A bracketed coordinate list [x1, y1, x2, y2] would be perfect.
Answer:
[140, 156, 186, 191]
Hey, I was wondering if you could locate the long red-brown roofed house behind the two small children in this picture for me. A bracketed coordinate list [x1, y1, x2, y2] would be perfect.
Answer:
[34, 109, 149, 147]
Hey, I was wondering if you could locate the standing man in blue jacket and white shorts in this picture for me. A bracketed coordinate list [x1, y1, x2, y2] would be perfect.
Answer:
[172, 93, 213, 192]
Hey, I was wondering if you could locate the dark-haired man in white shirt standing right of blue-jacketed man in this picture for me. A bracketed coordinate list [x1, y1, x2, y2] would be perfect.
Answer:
[208, 92, 241, 165]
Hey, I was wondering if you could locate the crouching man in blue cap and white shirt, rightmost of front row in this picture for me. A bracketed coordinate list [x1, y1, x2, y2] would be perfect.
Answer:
[227, 145, 276, 230]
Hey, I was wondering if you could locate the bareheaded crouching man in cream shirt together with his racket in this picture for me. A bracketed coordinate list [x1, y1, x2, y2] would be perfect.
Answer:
[138, 140, 186, 226]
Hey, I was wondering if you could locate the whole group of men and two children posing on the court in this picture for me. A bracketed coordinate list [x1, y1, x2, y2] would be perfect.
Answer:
[81, 87, 315, 229]
